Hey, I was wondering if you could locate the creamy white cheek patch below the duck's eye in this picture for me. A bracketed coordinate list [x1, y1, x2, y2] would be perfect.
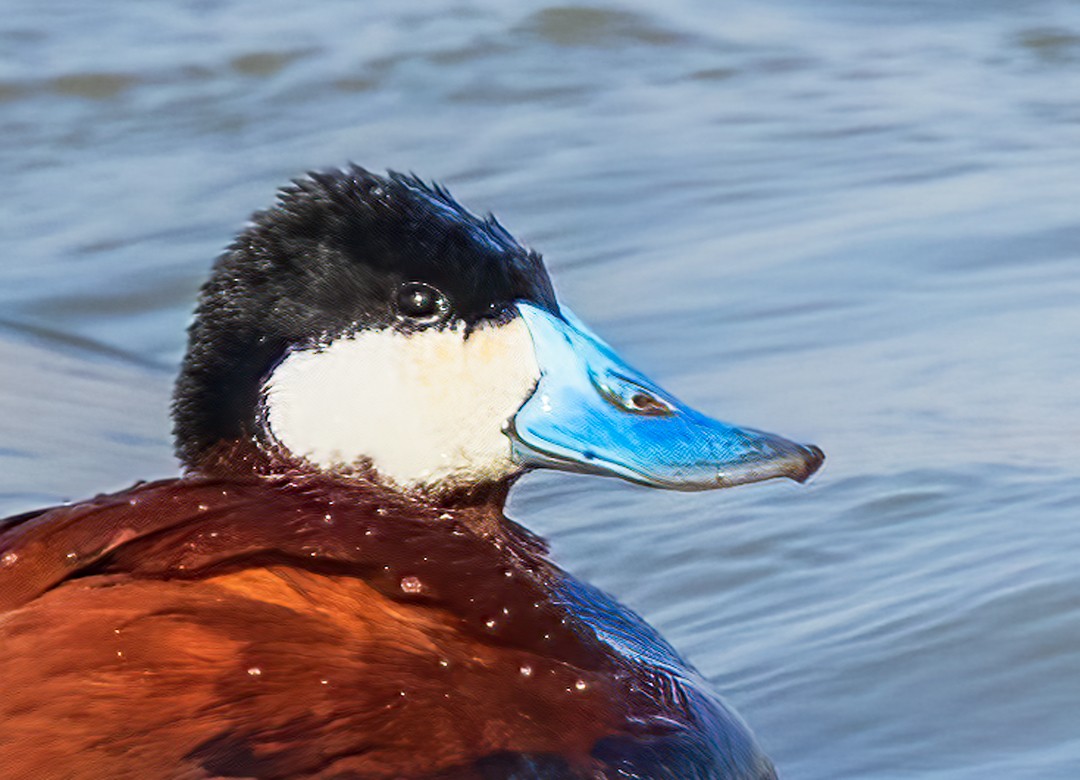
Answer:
[264, 318, 540, 487]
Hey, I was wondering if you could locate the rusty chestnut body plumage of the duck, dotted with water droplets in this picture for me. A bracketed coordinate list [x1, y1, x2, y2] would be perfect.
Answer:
[0, 479, 632, 779]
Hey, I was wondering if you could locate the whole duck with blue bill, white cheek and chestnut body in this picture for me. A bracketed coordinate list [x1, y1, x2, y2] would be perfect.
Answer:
[0, 169, 821, 780]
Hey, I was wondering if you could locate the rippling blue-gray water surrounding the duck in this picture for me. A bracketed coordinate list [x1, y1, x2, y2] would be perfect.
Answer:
[0, 0, 1080, 780]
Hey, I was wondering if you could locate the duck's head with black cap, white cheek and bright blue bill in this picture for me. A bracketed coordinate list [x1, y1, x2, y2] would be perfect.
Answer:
[174, 166, 824, 495]
